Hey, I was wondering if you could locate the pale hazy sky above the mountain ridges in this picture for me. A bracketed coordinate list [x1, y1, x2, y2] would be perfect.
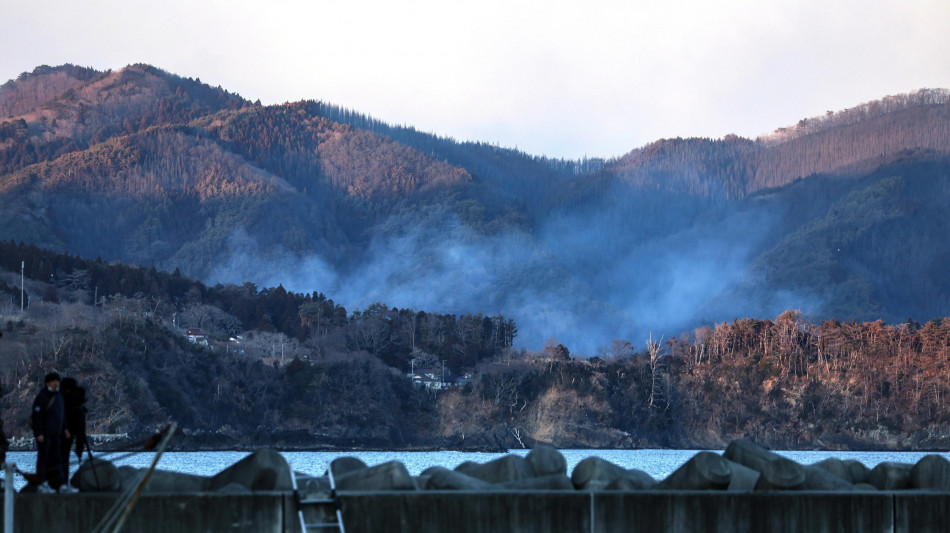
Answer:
[0, 0, 950, 158]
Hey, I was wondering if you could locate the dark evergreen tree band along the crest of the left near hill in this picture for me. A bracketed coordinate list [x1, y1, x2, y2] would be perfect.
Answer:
[0, 241, 518, 370]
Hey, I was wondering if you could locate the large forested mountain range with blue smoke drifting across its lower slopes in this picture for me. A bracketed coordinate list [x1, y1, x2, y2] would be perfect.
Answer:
[0, 65, 950, 355]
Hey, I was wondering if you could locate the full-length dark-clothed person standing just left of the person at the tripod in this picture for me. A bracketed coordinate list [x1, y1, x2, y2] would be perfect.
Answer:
[31, 372, 76, 494]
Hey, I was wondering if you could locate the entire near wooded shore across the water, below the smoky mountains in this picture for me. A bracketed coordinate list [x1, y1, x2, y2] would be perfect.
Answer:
[0, 242, 950, 451]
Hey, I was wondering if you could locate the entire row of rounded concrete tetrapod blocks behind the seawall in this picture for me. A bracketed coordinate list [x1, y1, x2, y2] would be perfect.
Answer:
[44, 439, 950, 497]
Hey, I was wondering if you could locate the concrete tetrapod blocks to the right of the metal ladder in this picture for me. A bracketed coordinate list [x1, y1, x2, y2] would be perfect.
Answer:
[302, 439, 950, 492]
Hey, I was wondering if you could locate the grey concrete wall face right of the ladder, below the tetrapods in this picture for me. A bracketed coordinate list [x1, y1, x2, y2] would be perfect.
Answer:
[341, 491, 950, 533]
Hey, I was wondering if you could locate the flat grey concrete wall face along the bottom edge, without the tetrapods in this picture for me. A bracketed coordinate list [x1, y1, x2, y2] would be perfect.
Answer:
[5, 491, 950, 533]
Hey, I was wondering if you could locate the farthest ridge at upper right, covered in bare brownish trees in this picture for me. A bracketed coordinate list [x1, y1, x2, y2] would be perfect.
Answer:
[608, 89, 950, 198]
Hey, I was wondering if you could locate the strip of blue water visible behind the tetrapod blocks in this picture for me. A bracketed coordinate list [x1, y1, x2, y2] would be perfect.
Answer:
[7, 444, 950, 489]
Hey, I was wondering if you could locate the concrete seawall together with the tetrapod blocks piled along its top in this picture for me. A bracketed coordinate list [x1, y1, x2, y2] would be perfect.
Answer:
[5, 441, 950, 533]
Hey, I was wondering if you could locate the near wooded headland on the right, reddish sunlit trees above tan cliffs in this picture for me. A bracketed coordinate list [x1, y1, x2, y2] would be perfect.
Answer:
[440, 311, 950, 449]
